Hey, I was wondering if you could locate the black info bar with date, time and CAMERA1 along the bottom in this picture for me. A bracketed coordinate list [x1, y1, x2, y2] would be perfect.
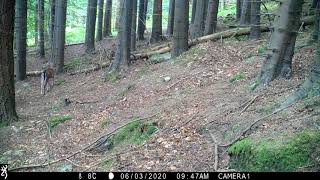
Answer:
[0, 171, 320, 180]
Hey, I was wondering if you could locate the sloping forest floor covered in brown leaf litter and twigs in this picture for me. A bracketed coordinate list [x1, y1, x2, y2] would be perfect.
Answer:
[0, 26, 317, 171]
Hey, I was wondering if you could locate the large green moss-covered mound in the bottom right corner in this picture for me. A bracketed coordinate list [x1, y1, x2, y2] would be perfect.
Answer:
[228, 131, 320, 172]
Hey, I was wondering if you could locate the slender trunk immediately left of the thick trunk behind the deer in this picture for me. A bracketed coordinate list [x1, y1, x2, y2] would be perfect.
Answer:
[49, 0, 56, 64]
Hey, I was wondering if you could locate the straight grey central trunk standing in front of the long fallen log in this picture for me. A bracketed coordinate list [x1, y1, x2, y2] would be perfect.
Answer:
[171, 0, 189, 58]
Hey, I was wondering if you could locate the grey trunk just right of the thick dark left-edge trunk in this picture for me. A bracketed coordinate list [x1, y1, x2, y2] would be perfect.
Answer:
[15, 0, 27, 81]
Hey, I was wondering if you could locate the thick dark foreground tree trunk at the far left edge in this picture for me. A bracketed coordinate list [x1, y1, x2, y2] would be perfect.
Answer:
[0, 0, 18, 125]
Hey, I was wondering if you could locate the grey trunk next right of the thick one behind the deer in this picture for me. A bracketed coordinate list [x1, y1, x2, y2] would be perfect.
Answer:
[84, 0, 97, 53]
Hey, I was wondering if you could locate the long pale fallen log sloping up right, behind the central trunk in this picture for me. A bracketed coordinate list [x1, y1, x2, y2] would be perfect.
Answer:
[135, 16, 314, 59]
